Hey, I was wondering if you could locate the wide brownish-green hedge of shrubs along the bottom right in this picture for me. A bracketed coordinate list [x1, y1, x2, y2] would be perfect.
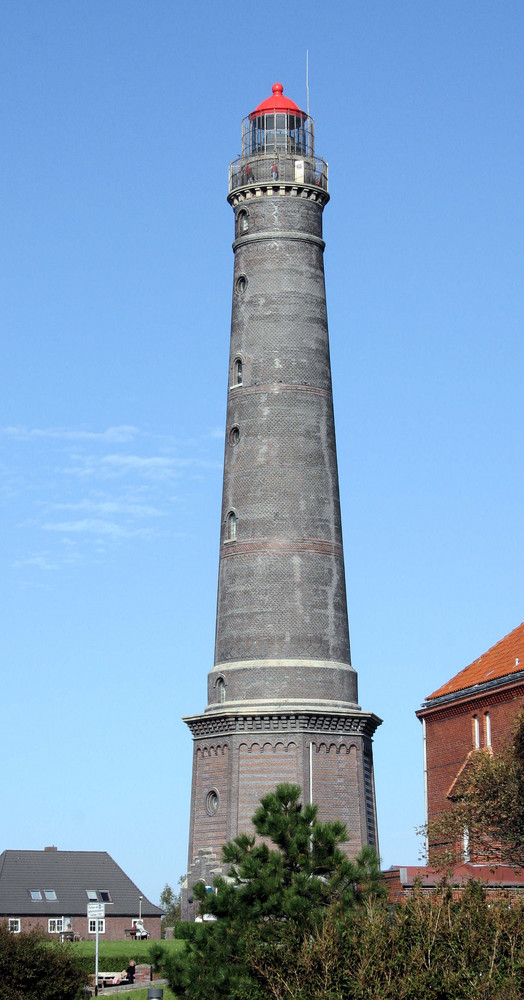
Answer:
[246, 882, 524, 1000]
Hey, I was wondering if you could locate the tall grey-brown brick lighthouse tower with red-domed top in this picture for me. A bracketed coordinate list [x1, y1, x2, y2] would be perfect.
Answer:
[185, 83, 380, 916]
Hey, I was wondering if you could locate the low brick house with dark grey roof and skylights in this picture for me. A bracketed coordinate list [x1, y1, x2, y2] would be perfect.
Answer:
[0, 847, 163, 941]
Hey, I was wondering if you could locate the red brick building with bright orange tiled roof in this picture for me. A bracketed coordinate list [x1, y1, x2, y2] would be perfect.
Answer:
[416, 623, 524, 856]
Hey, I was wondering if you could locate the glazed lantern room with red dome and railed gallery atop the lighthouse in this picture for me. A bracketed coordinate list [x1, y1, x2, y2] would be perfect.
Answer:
[229, 83, 327, 191]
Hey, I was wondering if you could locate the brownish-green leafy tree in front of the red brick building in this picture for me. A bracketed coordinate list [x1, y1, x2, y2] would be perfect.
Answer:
[427, 710, 524, 870]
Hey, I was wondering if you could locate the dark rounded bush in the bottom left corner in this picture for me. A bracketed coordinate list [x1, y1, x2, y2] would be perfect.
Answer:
[0, 922, 86, 1000]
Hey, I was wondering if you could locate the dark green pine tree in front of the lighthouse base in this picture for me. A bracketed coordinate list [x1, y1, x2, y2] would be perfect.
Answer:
[166, 784, 382, 1000]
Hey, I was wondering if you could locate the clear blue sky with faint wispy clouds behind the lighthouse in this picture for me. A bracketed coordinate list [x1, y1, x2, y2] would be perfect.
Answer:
[0, 0, 524, 900]
